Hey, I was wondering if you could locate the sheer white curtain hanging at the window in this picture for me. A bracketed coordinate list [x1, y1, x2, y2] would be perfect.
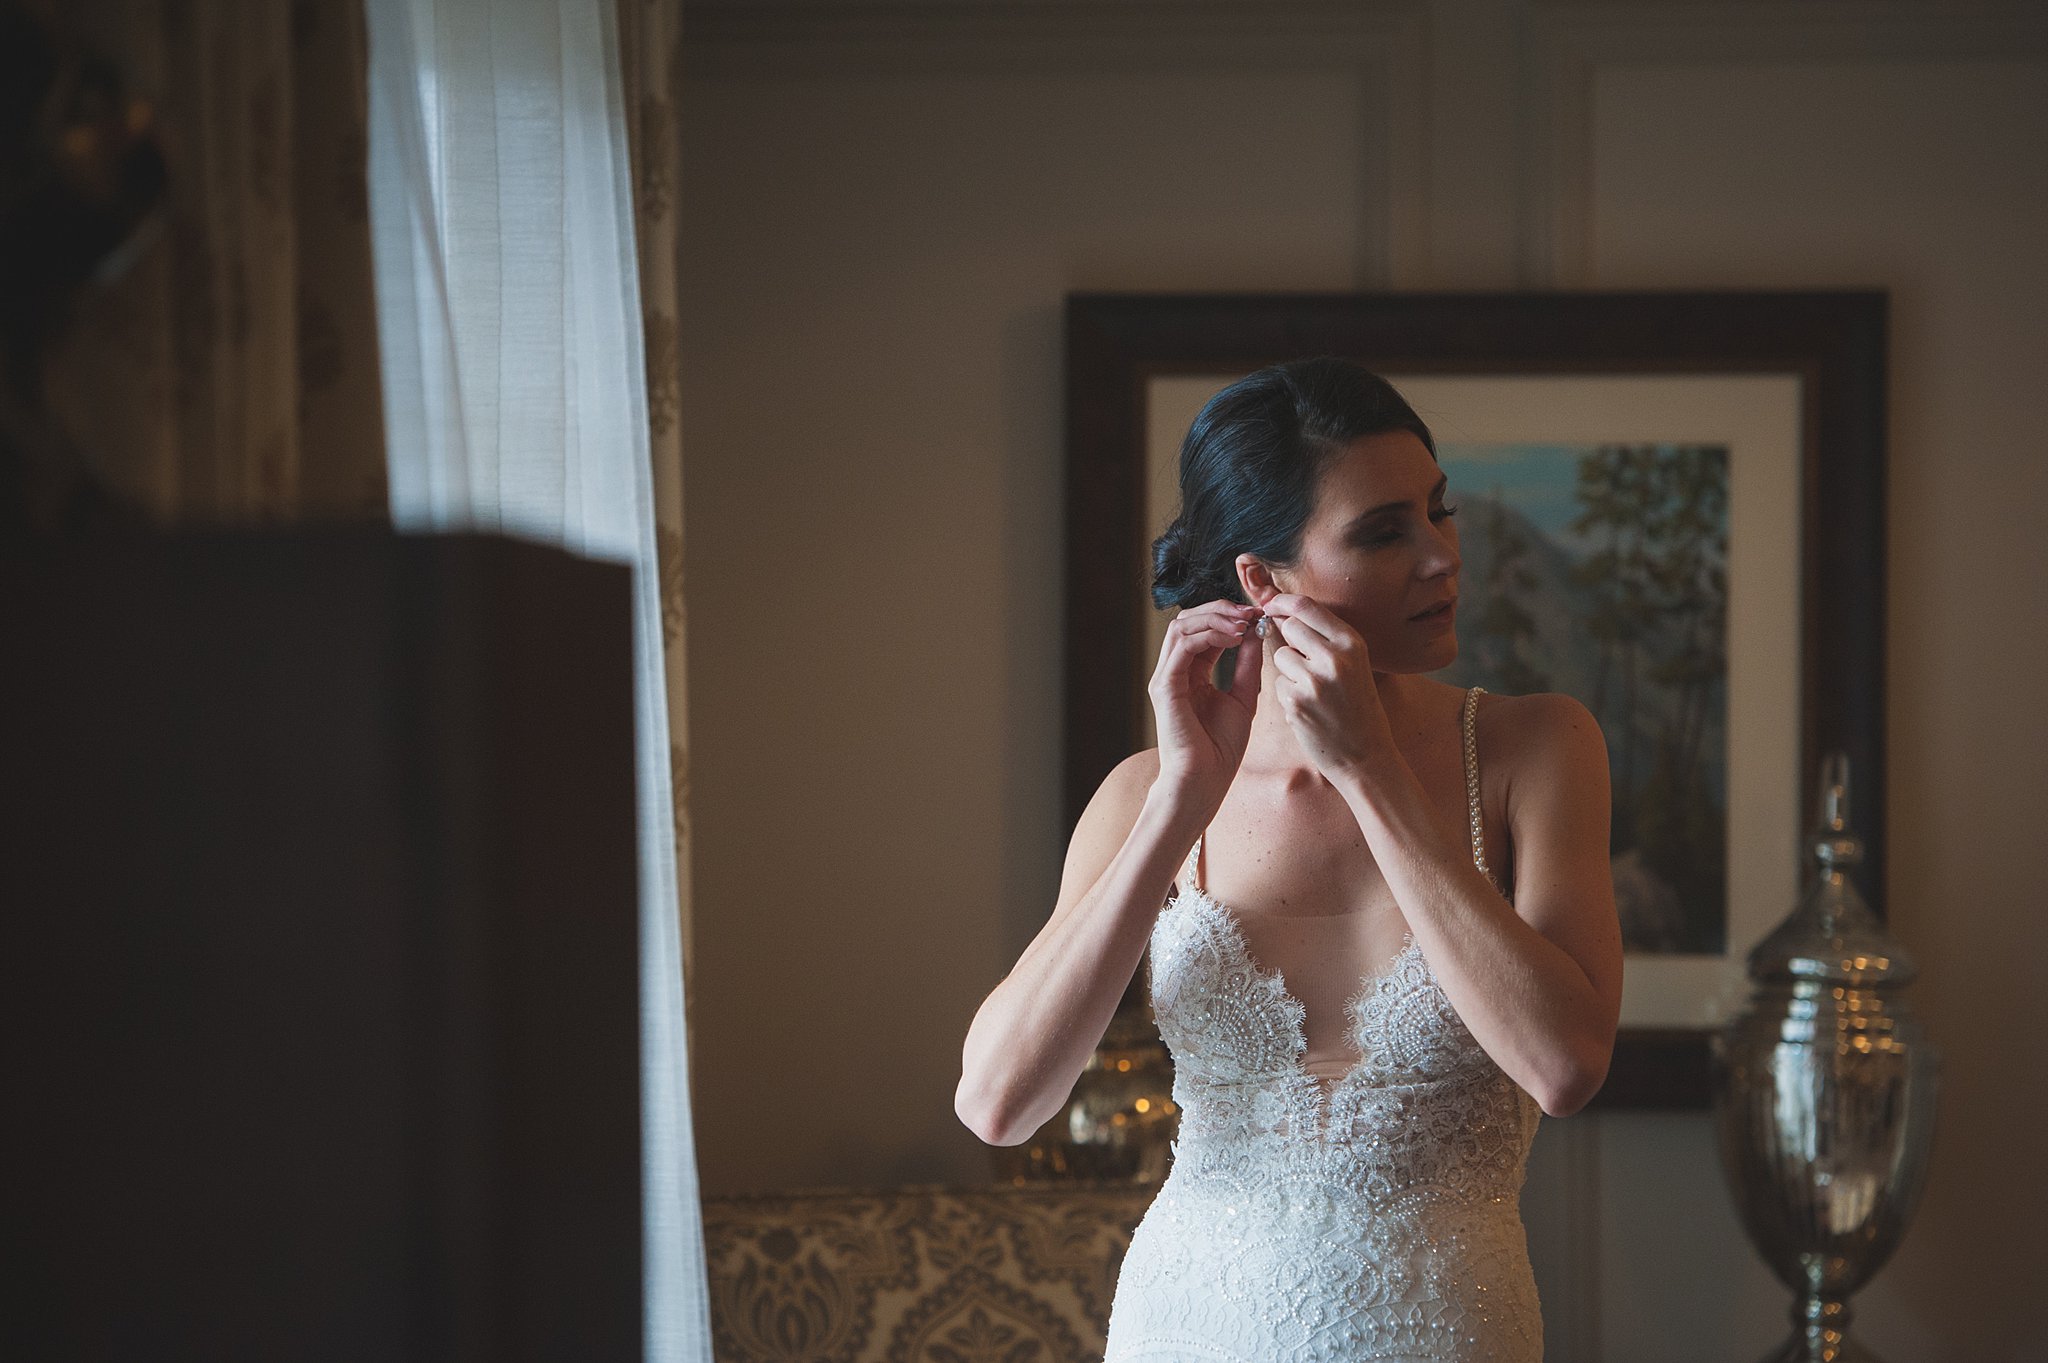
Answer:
[367, 0, 711, 1363]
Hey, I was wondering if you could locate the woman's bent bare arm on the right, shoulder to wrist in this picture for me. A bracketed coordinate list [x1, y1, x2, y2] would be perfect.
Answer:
[1333, 694, 1622, 1117]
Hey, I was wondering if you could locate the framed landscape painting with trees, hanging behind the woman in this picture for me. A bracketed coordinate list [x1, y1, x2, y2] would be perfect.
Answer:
[1065, 291, 1886, 1107]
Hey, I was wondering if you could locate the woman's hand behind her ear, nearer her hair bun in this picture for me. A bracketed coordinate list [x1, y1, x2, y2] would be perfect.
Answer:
[1145, 600, 1264, 812]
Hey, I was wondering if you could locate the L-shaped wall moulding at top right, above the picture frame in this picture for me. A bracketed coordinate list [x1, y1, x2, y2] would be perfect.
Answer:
[1520, 0, 2048, 289]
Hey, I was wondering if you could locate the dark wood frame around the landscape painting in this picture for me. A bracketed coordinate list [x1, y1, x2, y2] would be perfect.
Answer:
[1063, 291, 1886, 1109]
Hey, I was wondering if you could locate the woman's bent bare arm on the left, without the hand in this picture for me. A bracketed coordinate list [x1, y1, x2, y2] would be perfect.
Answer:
[952, 749, 1204, 1146]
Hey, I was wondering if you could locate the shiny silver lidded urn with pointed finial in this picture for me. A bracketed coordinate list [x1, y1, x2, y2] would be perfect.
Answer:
[1712, 753, 1942, 1363]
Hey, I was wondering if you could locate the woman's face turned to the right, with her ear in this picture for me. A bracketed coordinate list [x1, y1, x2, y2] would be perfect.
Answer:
[1239, 430, 1460, 671]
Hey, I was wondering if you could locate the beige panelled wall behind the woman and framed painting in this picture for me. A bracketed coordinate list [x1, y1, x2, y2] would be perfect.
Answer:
[682, 0, 2048, 1363]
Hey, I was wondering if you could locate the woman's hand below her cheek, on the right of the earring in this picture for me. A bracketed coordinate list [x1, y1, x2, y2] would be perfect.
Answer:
[1266, 591, 1395, 784]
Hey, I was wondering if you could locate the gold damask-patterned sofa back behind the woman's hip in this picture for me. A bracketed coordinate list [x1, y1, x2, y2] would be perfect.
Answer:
[705, 1183, 1157, 1363]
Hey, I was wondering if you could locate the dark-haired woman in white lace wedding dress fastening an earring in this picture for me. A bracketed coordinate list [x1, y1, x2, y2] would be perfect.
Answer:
[956, 360, 1622, 1363]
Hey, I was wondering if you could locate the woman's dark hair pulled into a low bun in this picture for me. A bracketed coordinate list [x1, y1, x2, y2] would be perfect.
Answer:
[1153, 356, 1436, 608]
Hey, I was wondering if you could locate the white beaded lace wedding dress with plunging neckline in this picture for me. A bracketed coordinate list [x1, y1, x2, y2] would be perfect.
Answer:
[1106, 688, 1542, 1363]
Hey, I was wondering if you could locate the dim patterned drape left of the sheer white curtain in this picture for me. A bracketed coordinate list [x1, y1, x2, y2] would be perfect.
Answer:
[47, 0, 389, 524]
